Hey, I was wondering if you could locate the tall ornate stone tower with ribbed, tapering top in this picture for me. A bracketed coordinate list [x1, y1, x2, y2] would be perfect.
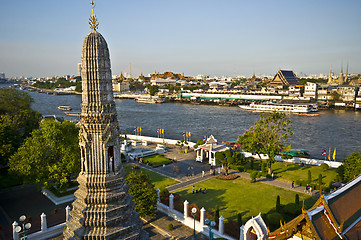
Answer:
[63, 30, 149, 240]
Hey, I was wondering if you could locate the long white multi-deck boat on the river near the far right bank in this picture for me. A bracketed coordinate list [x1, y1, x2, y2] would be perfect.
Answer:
[239, 102, 318, 113]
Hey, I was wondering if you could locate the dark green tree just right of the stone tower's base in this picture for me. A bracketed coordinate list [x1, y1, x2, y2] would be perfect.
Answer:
[125, 171, 157, 216]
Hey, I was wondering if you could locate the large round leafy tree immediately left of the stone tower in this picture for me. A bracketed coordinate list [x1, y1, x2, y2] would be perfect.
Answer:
[9, 120, 80, 188]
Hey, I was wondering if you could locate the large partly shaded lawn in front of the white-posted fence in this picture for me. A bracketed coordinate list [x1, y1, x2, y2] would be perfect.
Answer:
[177, 178, 315, 220]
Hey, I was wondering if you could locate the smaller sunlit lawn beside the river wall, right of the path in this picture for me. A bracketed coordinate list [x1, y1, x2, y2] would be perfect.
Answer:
[272, 162, 337, 187]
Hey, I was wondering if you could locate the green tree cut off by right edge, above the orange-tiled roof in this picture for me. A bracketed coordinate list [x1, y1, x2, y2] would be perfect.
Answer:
[338, 152, 361, 182]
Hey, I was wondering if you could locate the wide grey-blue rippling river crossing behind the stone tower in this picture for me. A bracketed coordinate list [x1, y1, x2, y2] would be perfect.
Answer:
[0, 85, 361, 161]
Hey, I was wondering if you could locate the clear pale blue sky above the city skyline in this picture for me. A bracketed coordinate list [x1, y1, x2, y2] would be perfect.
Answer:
[0, 0, 361, 77]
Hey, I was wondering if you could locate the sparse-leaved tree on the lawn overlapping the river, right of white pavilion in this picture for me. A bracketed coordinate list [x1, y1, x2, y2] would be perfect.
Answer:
[237, 112, 293, 174]
